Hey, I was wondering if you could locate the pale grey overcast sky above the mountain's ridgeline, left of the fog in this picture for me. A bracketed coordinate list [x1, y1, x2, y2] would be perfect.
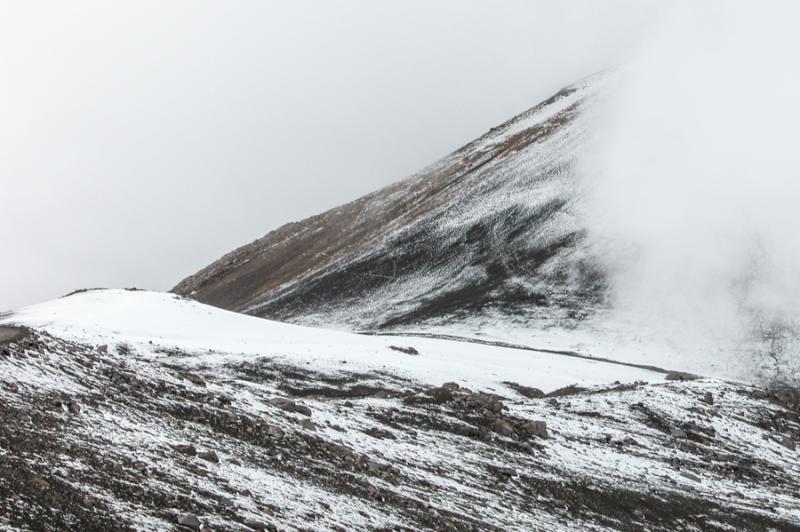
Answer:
[0, 0, 658, 309]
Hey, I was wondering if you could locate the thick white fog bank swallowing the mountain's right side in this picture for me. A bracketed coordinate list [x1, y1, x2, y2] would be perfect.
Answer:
[582, 2, 800, 381]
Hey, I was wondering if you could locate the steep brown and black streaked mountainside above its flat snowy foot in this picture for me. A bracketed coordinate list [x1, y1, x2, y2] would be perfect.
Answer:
[173, 81, 605, 330]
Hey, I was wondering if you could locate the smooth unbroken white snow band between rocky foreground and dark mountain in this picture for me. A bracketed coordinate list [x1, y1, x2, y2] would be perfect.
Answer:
[0, 290, 663, 392]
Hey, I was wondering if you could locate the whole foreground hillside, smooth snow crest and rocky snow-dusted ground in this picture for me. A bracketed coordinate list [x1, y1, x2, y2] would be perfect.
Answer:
[0, 290, 800, 530]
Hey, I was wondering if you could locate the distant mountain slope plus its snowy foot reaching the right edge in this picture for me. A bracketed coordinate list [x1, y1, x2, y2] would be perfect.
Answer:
[169, 74, 800, 387]
